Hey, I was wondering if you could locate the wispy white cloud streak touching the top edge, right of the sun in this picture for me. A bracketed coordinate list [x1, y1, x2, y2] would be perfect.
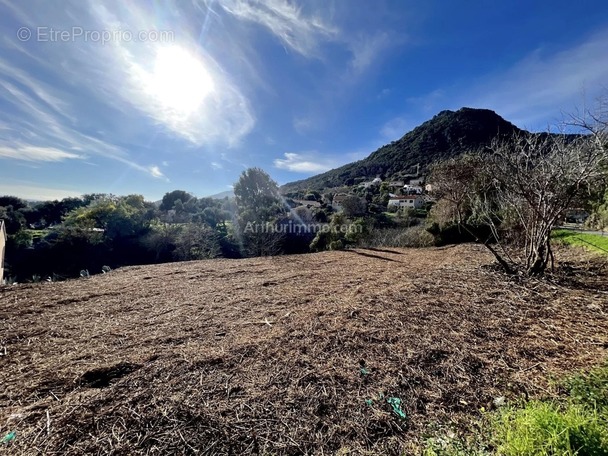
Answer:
[219, 0, 338, 57]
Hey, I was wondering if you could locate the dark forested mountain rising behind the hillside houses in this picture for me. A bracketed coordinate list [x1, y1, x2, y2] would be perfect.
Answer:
[281, 108, 522, 193]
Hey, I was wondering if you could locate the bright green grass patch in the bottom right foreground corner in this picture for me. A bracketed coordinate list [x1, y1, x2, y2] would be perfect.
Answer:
[425, 365, 608, 456]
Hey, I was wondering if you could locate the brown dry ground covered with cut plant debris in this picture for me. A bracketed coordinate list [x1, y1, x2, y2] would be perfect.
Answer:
[0, 245, 608, 455]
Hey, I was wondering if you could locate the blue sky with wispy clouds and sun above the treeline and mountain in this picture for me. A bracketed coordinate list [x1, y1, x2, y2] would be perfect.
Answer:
[0, 0, 608, 200]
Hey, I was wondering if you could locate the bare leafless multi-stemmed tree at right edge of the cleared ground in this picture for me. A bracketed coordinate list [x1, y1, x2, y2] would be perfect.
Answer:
[471, 131, 606, 275]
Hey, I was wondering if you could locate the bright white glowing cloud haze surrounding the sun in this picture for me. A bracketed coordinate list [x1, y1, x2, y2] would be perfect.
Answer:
[85, 3, 256, 146]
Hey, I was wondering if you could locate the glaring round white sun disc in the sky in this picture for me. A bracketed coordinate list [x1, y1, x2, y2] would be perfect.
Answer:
[147, 46, 214, 116]
